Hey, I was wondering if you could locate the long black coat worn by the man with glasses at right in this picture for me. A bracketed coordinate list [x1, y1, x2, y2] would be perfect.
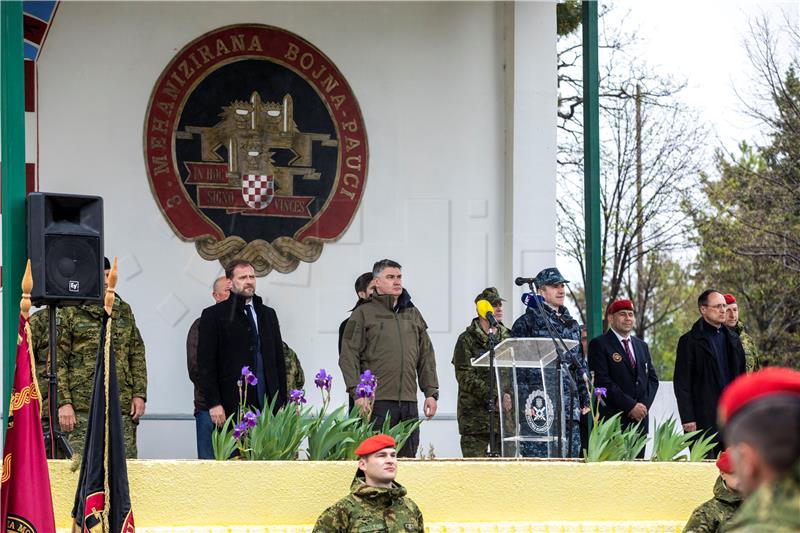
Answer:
[673, 318, 745, 438]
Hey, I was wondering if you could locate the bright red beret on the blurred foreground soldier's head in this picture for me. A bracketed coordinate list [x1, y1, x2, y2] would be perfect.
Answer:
[718, 367, 800, 426]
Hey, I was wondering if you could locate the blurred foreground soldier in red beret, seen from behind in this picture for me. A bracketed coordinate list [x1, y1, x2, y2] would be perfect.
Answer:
[719, 367, 800, 533]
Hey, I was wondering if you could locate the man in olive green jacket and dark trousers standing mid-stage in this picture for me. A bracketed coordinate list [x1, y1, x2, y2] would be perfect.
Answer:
[339, 259, 439, 457]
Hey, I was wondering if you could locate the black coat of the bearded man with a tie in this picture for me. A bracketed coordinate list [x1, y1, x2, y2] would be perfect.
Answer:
[197, 293, 286, 416]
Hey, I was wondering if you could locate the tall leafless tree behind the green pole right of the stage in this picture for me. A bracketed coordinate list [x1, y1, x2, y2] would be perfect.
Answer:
[557, 8, 706, 336]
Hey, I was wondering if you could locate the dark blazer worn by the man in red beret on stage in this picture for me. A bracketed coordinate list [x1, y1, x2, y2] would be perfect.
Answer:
[589, 329, 658, 432]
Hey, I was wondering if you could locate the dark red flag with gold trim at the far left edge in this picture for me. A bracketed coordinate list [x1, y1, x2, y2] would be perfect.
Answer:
[0, 315, 56, 533]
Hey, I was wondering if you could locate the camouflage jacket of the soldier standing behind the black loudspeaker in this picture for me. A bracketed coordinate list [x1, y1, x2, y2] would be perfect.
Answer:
[57, 295, 147, 411]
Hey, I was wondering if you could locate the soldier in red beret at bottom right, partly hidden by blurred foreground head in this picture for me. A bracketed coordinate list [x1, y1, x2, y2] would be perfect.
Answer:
[683, 450, 742, 533]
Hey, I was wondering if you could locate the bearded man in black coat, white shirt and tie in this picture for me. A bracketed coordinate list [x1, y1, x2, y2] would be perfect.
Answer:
[197, 259, 286, 426]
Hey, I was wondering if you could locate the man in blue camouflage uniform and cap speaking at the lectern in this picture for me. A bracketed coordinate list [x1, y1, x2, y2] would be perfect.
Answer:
[511, 267, 589, 457]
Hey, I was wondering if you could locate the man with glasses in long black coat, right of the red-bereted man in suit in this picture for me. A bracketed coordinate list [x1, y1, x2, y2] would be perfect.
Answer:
[673, 289, 745, 457]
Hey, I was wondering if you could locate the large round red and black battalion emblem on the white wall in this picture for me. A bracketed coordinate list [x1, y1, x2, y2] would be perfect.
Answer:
[144, 24, 368, 276]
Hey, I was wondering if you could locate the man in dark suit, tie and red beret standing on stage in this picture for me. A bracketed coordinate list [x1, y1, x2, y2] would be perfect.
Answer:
[589, 300, 658, 450]
